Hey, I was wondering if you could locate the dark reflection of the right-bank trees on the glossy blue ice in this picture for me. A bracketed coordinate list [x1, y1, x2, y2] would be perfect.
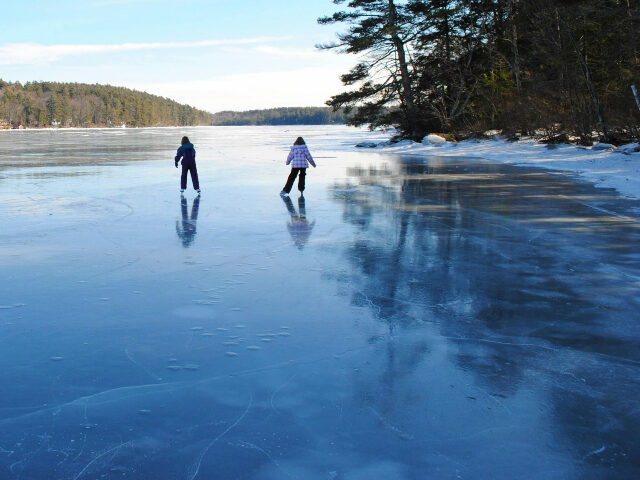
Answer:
[333, 157, 640, 478]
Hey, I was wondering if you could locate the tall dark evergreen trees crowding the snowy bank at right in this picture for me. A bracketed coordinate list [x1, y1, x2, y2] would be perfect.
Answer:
[318, 0, 640, 144]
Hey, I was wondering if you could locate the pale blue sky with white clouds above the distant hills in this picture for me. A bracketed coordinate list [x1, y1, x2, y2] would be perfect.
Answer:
[0, 0, 356, 112]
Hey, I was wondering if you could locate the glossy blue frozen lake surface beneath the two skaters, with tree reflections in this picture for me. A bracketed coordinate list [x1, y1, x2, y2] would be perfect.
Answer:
[0, 127, 640, 480]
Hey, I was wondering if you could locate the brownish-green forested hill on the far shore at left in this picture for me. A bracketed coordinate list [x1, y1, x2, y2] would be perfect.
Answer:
[0, 80, 211, 128]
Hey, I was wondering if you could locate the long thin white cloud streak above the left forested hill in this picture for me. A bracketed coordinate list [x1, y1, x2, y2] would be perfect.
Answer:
[0, 37, 282, 65]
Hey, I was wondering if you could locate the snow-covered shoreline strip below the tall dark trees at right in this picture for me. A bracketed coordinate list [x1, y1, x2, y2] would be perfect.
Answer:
[364, 135, 640, 198]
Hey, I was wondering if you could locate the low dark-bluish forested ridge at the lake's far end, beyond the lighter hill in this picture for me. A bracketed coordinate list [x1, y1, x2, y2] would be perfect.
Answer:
[211, 107, 346, 125]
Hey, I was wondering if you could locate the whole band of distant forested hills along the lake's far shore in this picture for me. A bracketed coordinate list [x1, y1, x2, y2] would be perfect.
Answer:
[0, 79, 346, 128]
